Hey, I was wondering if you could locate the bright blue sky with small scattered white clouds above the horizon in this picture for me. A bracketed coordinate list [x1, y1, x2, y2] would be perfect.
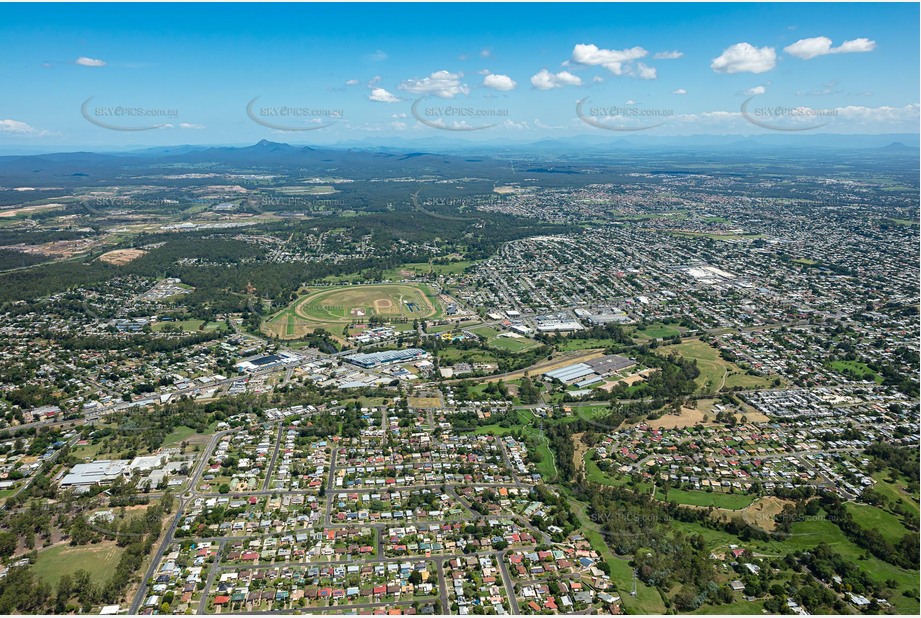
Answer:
[0, 4, 919, 147]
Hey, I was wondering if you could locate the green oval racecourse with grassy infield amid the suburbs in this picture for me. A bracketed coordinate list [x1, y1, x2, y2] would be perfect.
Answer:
[263, 284, 442, 339]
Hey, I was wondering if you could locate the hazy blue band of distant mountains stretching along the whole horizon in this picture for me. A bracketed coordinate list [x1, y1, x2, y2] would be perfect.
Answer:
[0, 134, 921, 186]
